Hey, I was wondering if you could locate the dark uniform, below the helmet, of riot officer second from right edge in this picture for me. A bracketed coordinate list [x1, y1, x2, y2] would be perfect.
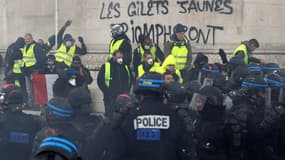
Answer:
[231, 97, 265, 160]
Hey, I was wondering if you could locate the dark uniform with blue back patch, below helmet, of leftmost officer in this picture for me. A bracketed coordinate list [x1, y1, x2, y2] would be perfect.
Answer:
[0, 106, 40, 160]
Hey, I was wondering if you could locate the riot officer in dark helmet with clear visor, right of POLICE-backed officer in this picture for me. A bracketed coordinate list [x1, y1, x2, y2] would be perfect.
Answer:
[190, 86, 236, 160]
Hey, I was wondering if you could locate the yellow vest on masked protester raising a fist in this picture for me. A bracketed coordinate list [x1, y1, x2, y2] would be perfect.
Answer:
[54, 44, 76, 67]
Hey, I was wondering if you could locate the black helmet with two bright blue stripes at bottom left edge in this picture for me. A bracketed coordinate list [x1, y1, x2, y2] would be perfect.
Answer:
[34, 135, 82, 160]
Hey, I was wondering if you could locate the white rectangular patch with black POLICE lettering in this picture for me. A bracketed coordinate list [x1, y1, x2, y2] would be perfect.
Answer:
[134, 115, 170, 130]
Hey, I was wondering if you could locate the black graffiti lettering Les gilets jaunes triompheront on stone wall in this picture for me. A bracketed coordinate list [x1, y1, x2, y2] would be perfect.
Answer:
[99, 0, 234, 45]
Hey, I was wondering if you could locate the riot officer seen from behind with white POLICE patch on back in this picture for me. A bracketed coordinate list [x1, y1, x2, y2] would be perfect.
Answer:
[118, 73, 182, 160]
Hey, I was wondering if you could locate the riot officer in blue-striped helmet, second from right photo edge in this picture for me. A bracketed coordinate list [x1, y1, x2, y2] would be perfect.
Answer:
[231, 75, 268, 160]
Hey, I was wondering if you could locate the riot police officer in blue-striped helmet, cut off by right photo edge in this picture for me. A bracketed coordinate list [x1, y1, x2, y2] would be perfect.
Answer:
[261, 73, 285, 159]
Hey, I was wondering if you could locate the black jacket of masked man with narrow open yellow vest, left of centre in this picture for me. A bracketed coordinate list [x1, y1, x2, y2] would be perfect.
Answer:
[97, 60, 132, 99]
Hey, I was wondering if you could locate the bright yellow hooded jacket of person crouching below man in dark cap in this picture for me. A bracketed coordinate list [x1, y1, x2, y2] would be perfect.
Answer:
[159, 55, 183, 84]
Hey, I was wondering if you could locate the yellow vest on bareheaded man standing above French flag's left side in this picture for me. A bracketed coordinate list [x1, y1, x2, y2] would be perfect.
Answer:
[21, 44, 37, 67]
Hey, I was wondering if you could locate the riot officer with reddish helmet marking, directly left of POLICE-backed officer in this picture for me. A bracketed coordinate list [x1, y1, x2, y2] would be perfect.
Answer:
[83, 94, 138, 160]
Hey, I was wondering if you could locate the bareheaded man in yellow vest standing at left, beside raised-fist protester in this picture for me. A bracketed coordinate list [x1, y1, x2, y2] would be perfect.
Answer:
[21, 33, 45, 76]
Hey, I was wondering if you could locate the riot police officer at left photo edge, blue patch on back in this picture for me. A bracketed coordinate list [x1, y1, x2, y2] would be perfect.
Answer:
[0, 84, 40, 160]
